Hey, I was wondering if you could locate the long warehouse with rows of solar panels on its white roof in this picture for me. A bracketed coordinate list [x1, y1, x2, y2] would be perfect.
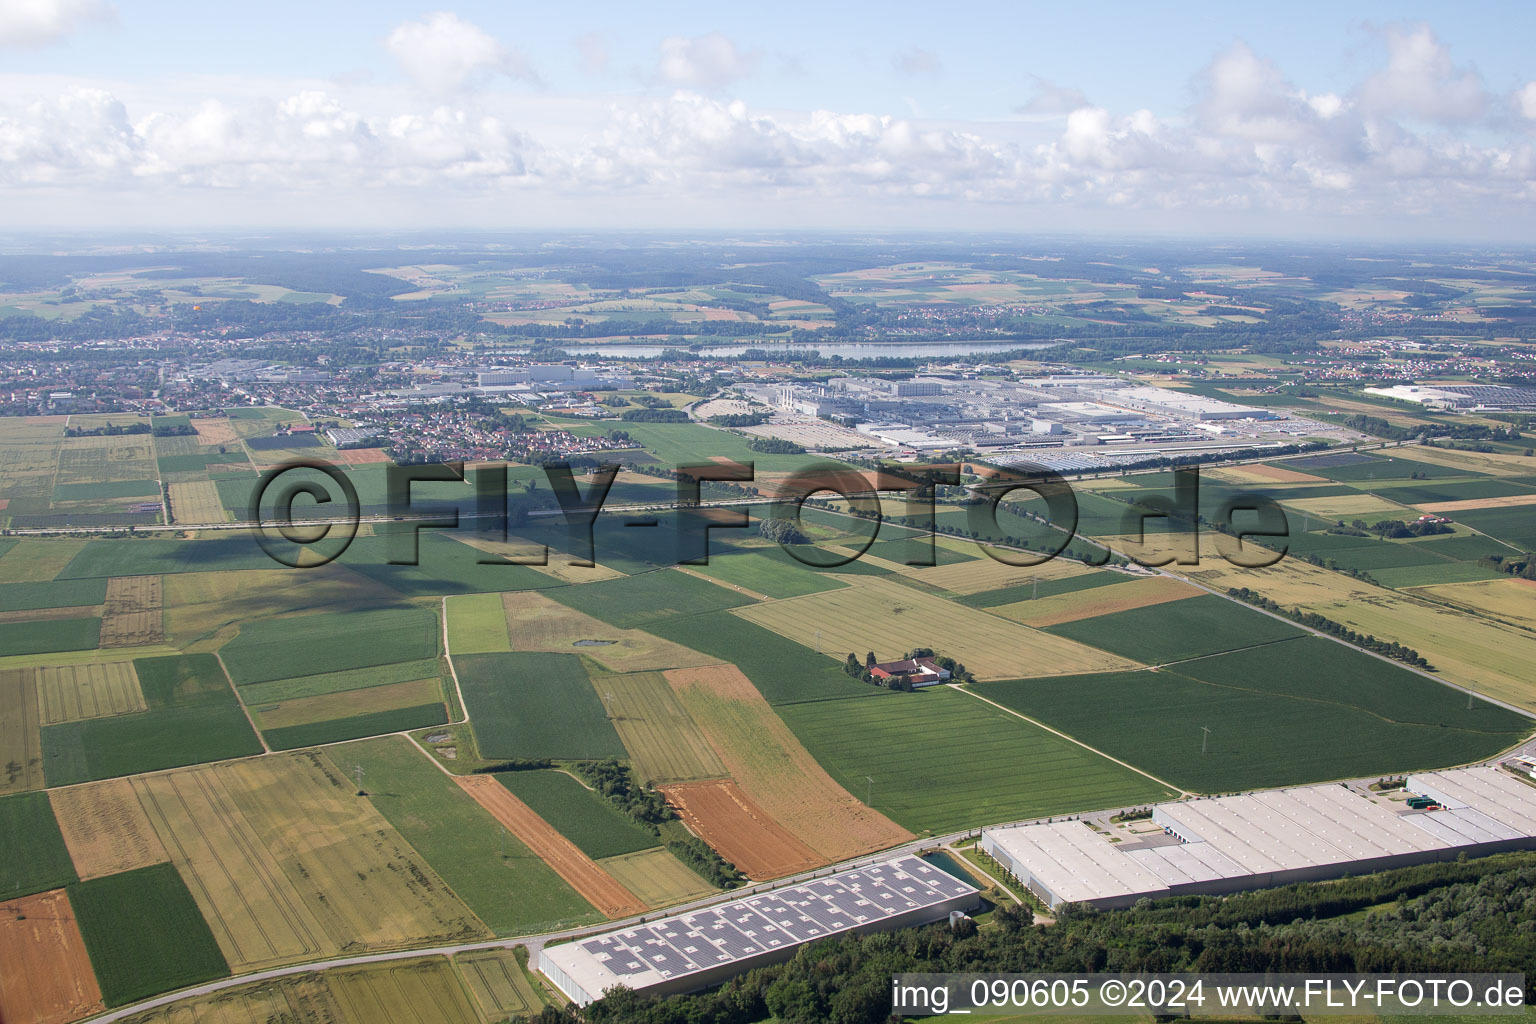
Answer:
[538, 855, 980, 1006]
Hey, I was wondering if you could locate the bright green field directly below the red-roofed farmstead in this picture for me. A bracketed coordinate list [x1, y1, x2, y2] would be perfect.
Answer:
[777, 688, 1172, 834]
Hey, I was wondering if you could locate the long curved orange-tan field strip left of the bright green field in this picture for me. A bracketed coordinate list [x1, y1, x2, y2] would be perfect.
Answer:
[667, 665, 912, 863]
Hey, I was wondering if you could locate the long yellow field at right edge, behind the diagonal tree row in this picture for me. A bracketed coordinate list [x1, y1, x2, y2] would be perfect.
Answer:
[1178, 553, 1536, 709]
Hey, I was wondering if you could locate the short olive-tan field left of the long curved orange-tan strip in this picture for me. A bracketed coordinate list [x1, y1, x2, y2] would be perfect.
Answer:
[591, 672, 727, 785]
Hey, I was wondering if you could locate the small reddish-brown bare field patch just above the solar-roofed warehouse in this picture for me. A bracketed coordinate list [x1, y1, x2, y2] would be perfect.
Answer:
[659, 781, 822, 881]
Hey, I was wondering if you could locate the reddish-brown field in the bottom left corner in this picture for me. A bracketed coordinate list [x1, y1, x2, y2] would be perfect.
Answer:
[0, 889, 103, 1024]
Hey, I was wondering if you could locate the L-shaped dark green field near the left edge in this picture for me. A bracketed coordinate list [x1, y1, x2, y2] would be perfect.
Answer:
[43, 654, 261, 786]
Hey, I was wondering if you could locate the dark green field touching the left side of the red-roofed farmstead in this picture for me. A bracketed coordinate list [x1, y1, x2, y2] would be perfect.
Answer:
[647, 611, 877, 705]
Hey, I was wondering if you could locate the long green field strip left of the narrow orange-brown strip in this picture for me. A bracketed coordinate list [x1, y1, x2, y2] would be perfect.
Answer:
[335, 737, 602, 935]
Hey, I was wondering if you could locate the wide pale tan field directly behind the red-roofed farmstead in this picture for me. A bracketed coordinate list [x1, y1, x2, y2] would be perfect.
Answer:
[731, 577, 1138, 679]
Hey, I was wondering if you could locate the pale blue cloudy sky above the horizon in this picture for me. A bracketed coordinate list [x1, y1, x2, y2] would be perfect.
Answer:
[0, 0, 1536, 244]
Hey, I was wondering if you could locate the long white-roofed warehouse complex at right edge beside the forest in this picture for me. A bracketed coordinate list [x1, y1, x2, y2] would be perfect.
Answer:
[982, 766, 1536, 907]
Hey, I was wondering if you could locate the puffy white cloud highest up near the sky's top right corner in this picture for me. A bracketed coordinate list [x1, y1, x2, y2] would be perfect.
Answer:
[1359, 25, 1488, 124]
